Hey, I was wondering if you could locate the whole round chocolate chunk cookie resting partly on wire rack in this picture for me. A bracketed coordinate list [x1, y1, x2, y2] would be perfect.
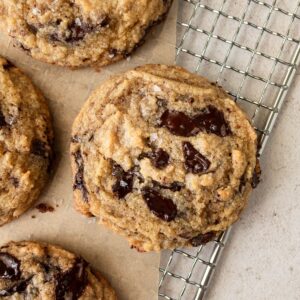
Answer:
[71, 65, 257, 251]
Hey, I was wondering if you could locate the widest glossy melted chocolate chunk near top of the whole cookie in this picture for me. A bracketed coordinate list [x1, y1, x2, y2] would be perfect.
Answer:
[159, 105, 231, 137]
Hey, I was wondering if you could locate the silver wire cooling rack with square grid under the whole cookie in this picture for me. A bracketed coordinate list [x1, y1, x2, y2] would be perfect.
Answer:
[159, 0, 300, 300]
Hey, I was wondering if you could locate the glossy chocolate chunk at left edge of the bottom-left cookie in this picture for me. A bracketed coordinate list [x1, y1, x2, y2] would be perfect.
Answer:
[0, 253, 20, 280]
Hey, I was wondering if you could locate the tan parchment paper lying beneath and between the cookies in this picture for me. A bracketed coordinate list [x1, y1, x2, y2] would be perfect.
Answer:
[0, 3, 177, 300]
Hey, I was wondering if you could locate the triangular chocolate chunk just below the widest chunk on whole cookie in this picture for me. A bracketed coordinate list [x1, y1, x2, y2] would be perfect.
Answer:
[182, 142, 210, 174]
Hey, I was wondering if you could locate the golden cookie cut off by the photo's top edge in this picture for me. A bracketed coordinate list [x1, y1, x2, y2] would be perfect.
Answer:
[0, 0, 172, 67]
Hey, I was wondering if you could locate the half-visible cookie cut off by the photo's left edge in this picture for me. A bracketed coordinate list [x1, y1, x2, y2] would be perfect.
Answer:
[0, 57, 53, 225]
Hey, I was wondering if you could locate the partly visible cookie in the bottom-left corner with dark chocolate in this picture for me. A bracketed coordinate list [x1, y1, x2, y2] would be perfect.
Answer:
[0, 241, 116, 300]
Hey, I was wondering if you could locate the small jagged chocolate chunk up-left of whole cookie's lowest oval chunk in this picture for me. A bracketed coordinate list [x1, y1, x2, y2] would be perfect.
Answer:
[112, 162, 134, 199]
